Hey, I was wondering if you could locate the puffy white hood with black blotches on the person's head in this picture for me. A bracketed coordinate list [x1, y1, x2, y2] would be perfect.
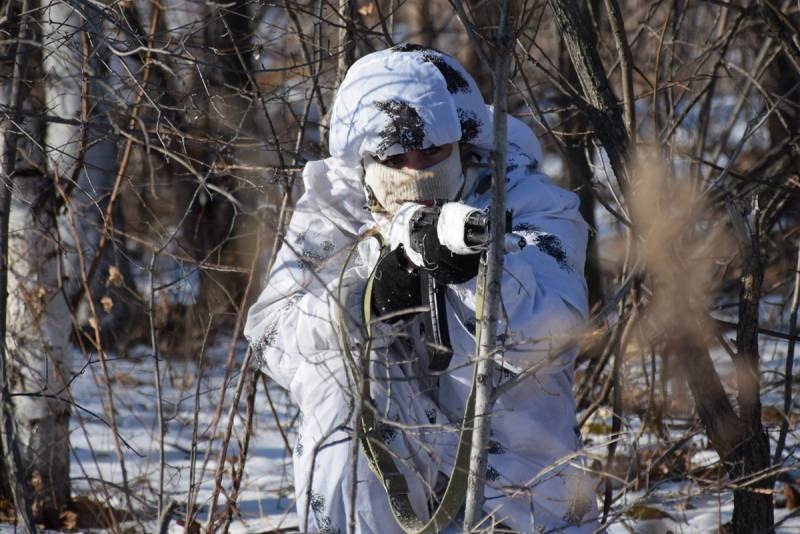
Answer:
[329, 45, 492, 165]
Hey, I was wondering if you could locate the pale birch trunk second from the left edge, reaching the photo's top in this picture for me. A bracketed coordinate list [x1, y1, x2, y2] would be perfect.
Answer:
[42, 2, 141, 347]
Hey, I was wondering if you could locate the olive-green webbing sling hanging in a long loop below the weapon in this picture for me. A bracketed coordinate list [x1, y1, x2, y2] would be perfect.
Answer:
[337, 237, 486, 534]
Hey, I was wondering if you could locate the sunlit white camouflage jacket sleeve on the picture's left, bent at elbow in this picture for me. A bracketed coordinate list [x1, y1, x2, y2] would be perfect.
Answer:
[245, 159, 376, 391]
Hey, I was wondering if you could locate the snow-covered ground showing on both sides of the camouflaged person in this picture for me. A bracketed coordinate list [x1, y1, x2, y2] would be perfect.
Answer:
[0, 332, 800, 534]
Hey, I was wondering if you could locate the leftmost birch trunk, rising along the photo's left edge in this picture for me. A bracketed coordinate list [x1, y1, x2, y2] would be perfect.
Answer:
[2, 0, 71, 530]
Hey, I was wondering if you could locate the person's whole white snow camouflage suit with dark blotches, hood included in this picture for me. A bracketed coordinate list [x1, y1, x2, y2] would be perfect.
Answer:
[245, 46, 597, 534]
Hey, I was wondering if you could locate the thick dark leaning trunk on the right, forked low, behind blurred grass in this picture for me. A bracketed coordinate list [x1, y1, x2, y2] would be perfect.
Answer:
[550, 0, 776, 533]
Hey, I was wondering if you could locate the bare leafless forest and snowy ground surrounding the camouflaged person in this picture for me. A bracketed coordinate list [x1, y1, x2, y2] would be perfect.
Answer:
[0, 0, 800, 532]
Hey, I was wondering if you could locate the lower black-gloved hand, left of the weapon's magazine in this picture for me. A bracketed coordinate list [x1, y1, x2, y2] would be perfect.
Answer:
[372, 245, 422, 323]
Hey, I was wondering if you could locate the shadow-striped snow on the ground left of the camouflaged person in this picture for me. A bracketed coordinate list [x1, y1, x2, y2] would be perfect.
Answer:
[62, 344, 293, 532]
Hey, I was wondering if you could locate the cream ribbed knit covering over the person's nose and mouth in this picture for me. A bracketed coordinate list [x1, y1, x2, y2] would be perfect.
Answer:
[364, 145, 464, 214]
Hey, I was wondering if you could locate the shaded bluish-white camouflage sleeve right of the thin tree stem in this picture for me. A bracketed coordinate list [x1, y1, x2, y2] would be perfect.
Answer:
[438, 118, 588, 372]
